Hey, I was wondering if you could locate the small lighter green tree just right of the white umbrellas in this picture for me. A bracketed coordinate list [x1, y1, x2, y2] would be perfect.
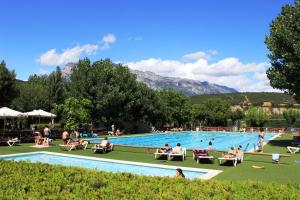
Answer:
[55, 97, 92, 131]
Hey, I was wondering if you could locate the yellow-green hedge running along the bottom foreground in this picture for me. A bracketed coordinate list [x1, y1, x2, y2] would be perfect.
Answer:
[0, 161, 300, 199]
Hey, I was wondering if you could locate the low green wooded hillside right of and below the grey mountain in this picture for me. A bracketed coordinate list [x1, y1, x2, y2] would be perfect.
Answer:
[191, 92, 296, 106]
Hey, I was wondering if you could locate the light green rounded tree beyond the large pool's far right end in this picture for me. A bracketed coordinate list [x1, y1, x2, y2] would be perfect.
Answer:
[246, 107, 271, 126]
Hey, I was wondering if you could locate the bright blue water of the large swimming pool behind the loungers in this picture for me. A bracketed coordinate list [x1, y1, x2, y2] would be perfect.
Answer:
[90, 132, 276, 151]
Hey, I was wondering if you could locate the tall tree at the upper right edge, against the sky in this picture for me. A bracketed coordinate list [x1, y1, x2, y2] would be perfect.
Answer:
[265, 0, 300, 102]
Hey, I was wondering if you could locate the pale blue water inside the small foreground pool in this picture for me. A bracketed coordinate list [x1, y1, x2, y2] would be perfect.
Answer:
[0, 153, 206, 179]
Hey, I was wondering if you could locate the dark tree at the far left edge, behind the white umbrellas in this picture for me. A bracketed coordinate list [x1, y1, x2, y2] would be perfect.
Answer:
[0, 61, 18, 107]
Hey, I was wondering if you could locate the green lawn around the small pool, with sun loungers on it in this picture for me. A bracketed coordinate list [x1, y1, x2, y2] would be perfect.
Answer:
[0, 135, 300, 183]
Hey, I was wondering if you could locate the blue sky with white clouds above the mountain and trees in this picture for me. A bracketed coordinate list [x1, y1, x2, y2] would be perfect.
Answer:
[0, 0, 293, 92]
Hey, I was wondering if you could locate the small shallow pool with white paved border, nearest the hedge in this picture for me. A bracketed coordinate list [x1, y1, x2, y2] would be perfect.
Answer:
[0, 152, 222, 179]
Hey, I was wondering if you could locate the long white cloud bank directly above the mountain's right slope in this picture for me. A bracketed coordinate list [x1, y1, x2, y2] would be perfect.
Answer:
[125, 52, 278, 92]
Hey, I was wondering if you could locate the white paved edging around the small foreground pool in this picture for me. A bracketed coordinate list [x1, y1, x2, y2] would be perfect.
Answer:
[0, 151, 223, 180]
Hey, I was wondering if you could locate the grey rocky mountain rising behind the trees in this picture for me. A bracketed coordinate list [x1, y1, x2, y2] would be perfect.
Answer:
[62, 63, 238, 96]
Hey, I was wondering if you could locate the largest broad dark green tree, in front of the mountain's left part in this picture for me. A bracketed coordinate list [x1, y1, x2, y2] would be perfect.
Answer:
[69, 59, 158, 125]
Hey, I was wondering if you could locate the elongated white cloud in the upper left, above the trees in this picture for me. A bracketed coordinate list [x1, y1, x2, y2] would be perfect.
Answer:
[35, 34, 116, 65]
